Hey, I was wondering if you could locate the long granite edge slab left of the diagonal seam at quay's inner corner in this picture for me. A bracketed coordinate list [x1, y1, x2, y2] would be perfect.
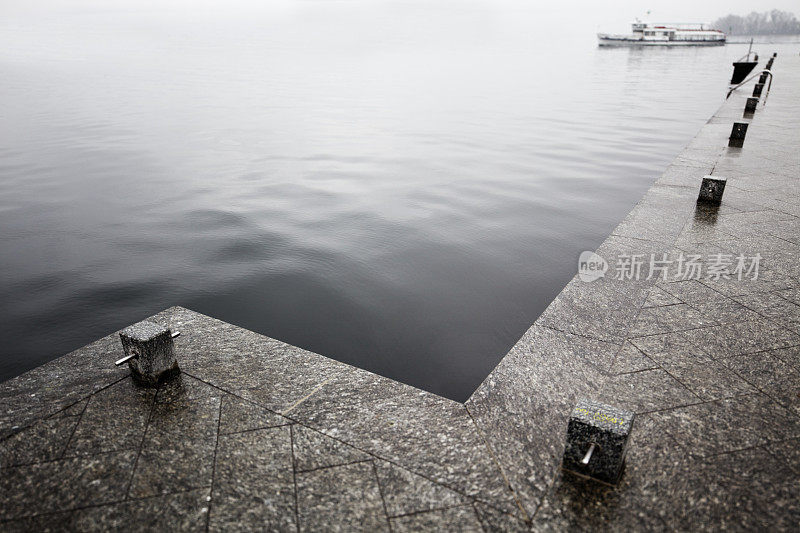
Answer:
[290, 371, 516, 512]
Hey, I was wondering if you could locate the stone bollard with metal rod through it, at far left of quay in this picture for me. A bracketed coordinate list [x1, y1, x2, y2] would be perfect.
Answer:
[115, 320, 180, 386]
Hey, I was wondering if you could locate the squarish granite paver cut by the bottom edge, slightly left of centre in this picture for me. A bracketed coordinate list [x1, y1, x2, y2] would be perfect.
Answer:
[297, 461, 389, 531]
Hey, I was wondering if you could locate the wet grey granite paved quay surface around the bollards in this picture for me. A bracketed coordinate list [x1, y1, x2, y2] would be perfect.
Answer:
[0, 56, 800, 531]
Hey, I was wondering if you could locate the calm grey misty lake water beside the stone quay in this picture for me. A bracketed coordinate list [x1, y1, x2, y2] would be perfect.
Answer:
[0, 2, 796, 400]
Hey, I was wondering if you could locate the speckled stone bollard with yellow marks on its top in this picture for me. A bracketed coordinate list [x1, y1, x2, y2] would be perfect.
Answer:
[561, 400, 634, 485]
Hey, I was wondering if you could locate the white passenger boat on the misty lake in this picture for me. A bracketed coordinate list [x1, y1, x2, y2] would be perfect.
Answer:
[597, 20, 725, 46]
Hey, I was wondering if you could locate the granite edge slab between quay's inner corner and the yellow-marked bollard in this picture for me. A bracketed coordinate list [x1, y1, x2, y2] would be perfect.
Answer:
[466, 325, 618, 519]
